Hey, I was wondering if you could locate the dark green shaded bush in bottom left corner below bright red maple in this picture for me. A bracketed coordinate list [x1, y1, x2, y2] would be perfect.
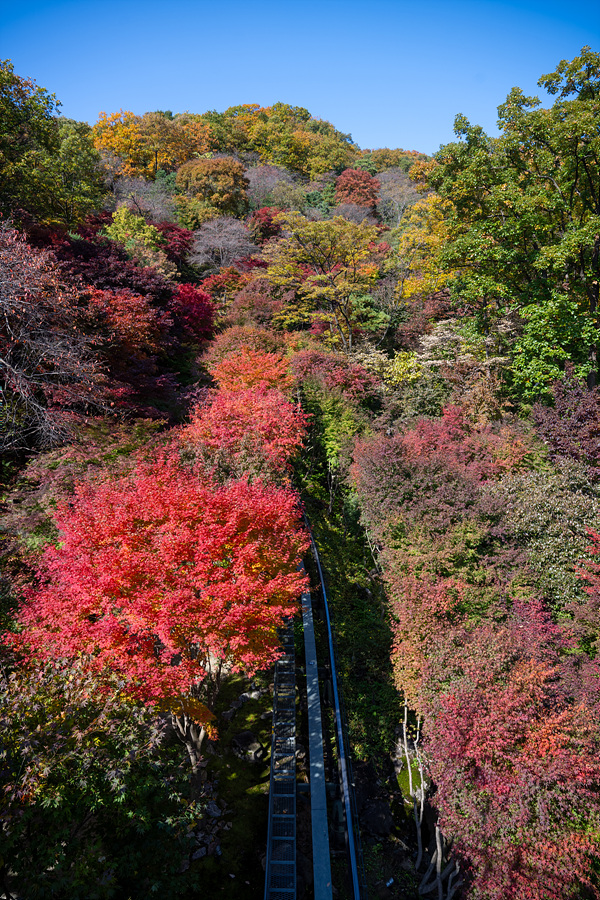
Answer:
[0, 660, 202, 900]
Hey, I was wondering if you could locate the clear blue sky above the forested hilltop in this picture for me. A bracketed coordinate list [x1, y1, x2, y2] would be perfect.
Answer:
[0, 0, 600, 153]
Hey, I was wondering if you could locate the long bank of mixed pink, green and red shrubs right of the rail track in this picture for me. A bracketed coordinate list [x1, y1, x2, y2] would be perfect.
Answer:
[352, 407, 600, 900]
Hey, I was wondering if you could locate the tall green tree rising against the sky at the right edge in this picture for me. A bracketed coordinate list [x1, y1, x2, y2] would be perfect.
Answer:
[425, 47, 600, 399]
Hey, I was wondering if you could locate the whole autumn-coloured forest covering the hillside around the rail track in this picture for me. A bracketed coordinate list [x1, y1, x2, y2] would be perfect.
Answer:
[0, 47, 600, 900]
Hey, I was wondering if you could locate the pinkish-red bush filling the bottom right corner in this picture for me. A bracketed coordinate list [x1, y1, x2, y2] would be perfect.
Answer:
[427, 602, 600, 900]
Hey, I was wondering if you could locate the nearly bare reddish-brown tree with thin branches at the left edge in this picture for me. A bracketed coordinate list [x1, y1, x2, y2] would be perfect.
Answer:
[0, 227, 104, 451]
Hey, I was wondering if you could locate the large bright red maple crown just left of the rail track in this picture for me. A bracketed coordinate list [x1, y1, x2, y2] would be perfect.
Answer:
[12, 455, 305, 701]
